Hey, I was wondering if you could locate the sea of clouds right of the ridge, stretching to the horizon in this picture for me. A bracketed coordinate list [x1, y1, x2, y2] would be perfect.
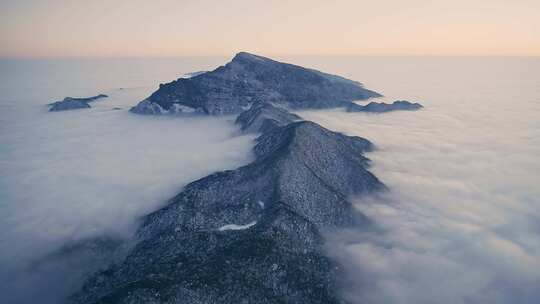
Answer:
[300, 57, 540, 304]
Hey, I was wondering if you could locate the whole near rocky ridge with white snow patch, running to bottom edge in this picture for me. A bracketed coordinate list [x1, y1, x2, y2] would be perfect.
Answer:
[72, 105, 384, 303]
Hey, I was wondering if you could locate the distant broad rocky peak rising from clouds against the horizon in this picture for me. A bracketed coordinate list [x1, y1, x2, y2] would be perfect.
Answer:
[131, 52, 380, 115]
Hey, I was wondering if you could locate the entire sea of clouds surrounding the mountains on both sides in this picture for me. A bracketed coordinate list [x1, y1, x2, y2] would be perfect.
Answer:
[0, 56, 540, 304]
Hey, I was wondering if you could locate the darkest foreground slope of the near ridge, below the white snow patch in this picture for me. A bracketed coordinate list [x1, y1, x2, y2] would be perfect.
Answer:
[73, 202, 339, 303]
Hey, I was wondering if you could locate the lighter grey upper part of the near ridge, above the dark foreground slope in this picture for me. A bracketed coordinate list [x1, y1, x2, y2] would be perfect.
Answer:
[139, 121, 382, 234]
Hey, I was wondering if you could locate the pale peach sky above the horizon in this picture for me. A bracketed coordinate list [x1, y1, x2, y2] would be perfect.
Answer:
[0, 0, 540, 58]
